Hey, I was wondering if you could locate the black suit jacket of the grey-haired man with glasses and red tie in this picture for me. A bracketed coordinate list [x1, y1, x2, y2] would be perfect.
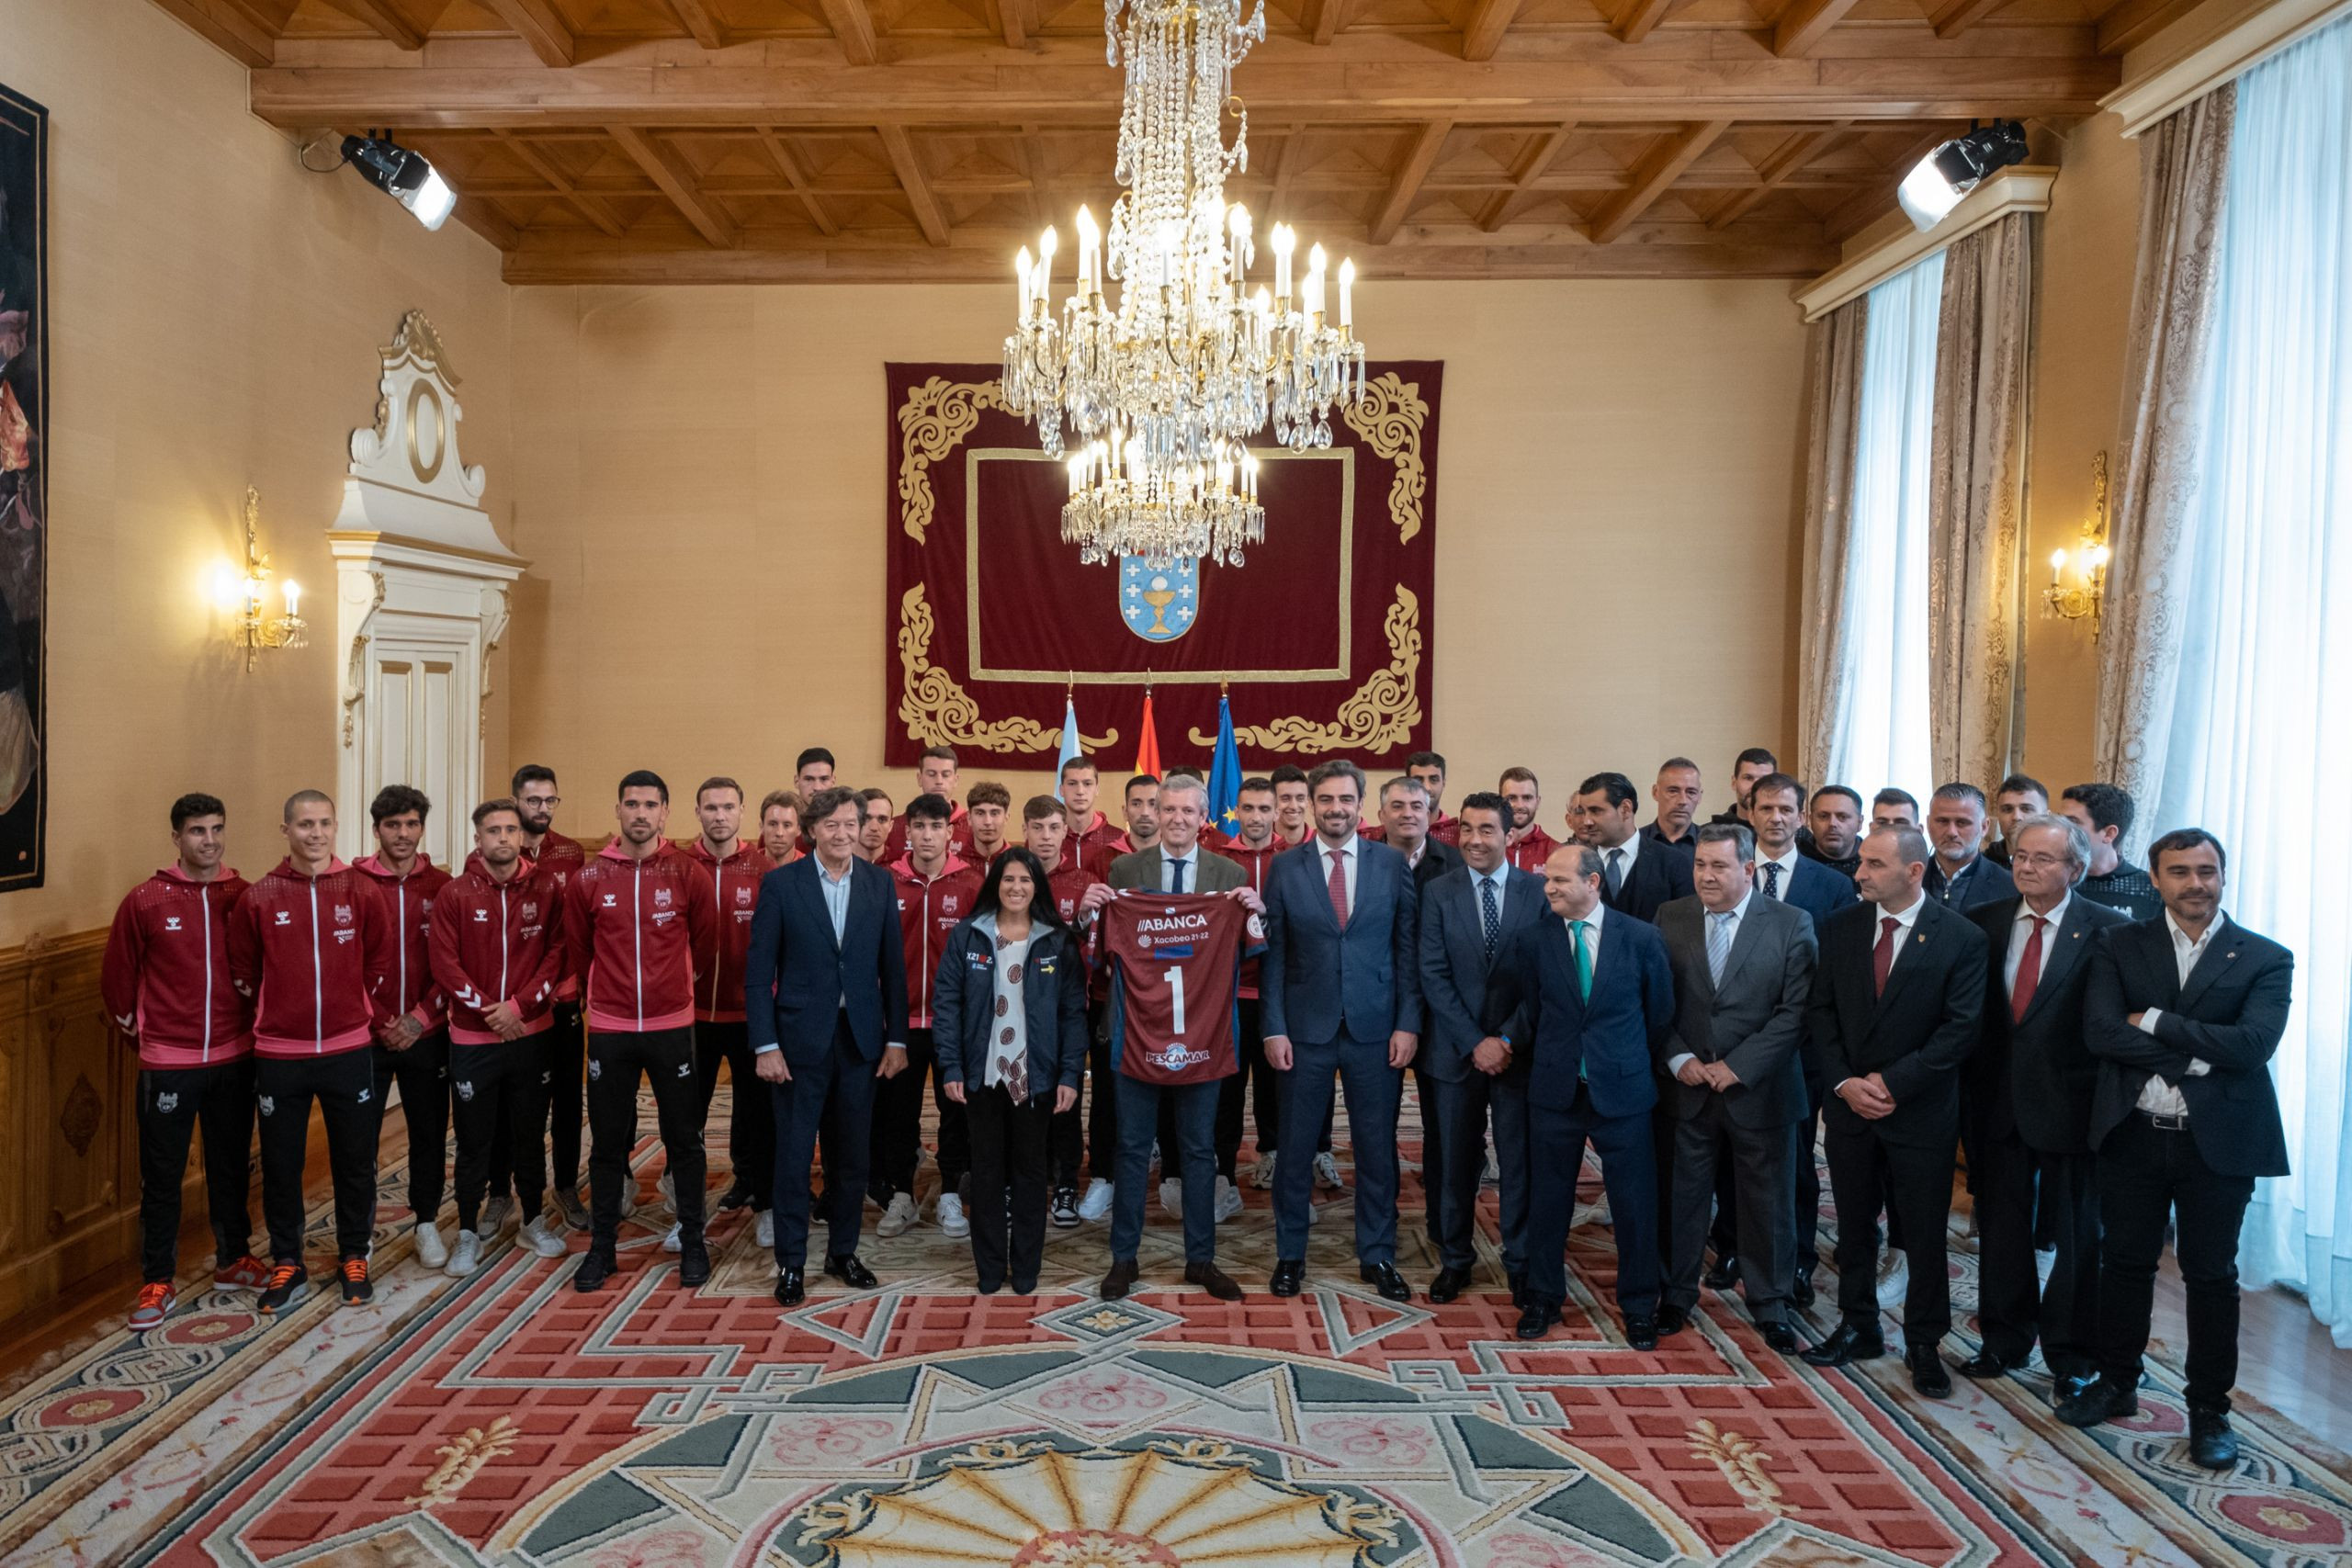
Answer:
[1962, 898, 2126, 1155]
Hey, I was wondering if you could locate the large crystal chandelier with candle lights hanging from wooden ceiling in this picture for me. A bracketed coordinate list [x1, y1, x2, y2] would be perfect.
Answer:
[1004, 0, 1364, 567]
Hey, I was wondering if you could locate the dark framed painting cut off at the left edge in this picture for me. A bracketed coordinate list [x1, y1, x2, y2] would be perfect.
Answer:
[0, 85, 50, 894]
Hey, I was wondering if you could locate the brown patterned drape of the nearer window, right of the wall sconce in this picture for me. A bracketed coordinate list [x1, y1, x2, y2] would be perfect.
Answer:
[2096, 83, 2237, 831]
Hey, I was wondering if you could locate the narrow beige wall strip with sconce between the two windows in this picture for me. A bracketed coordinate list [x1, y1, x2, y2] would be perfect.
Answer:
[1987, 115, 2141, 790]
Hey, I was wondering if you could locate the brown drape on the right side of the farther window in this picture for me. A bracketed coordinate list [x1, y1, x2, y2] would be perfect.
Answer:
[1927, 211, 2034, 790]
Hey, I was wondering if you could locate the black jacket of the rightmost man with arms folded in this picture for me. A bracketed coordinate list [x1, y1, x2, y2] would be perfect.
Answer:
[2084, 915, 2296, 1176]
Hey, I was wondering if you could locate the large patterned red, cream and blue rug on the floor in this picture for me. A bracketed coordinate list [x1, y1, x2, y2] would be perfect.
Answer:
[0, 1105, 2352, 1568]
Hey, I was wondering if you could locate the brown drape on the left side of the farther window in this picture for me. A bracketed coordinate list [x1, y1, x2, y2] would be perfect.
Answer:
[1797, 296, 1870, 781]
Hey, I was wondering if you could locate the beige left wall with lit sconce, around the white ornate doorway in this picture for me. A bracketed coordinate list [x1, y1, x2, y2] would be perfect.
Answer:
[0, 0, 515, 942]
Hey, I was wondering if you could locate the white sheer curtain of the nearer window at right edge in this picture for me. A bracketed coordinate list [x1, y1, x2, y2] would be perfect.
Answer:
[2152, 12, 2352, 1345]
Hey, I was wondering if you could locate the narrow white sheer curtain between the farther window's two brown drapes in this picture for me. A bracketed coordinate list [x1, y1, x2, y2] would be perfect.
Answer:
[1823, 252, 1943, 808]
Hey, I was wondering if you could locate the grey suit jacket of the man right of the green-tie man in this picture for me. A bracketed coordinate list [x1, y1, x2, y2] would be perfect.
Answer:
[1656, 894, 1820, 1128]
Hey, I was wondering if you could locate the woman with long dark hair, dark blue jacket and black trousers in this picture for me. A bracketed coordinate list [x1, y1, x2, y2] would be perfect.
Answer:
[932, 849, 1087, 1295]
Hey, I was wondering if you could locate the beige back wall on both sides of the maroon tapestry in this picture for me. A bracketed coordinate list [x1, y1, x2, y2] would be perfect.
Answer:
[511, 282, 1804, 835]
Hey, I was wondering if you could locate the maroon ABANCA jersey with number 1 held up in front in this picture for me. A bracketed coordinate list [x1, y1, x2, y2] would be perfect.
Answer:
[1099, 891, 1265, 1084]
